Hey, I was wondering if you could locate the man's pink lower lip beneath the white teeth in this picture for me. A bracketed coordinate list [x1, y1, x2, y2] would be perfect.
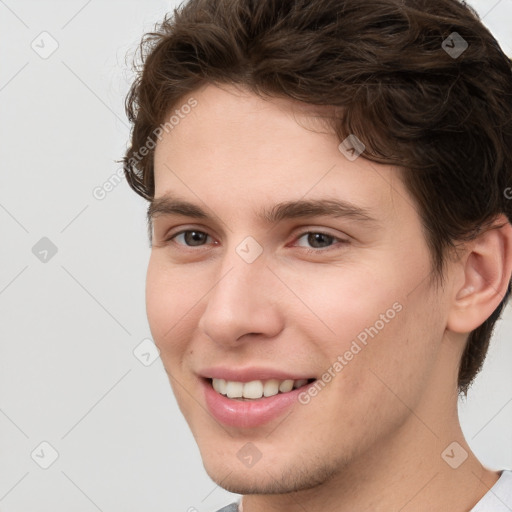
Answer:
[202, 379, 309, 428]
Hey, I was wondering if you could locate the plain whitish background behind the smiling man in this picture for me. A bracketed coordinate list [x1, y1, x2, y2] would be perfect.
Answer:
[0, 0, 512, 512]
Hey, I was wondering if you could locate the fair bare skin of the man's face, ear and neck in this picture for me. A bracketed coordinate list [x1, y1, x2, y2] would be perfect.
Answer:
[146, 84, 512, 512]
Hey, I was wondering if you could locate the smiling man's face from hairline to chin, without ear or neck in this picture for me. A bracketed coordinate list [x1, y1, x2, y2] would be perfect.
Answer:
[146, 85, 452, 494]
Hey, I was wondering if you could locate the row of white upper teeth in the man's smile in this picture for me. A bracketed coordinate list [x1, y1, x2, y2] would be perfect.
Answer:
[212, 379, 308, 399]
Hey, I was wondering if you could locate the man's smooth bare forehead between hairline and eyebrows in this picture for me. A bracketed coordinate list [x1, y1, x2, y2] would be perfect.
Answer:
[151, 84, 412, 224]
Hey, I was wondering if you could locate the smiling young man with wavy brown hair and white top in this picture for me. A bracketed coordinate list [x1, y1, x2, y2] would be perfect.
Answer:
[124, 0, 512, 512]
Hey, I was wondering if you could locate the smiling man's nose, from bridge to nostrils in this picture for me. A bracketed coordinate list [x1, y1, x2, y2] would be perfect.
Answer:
[198, 251, 283, 346]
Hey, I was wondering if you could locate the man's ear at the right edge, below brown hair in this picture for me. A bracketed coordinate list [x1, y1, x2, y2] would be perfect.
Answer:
[446, 214, 512, 333]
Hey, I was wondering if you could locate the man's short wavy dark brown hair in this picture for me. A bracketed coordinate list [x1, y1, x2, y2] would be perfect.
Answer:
[123, 0, 512, 394]
